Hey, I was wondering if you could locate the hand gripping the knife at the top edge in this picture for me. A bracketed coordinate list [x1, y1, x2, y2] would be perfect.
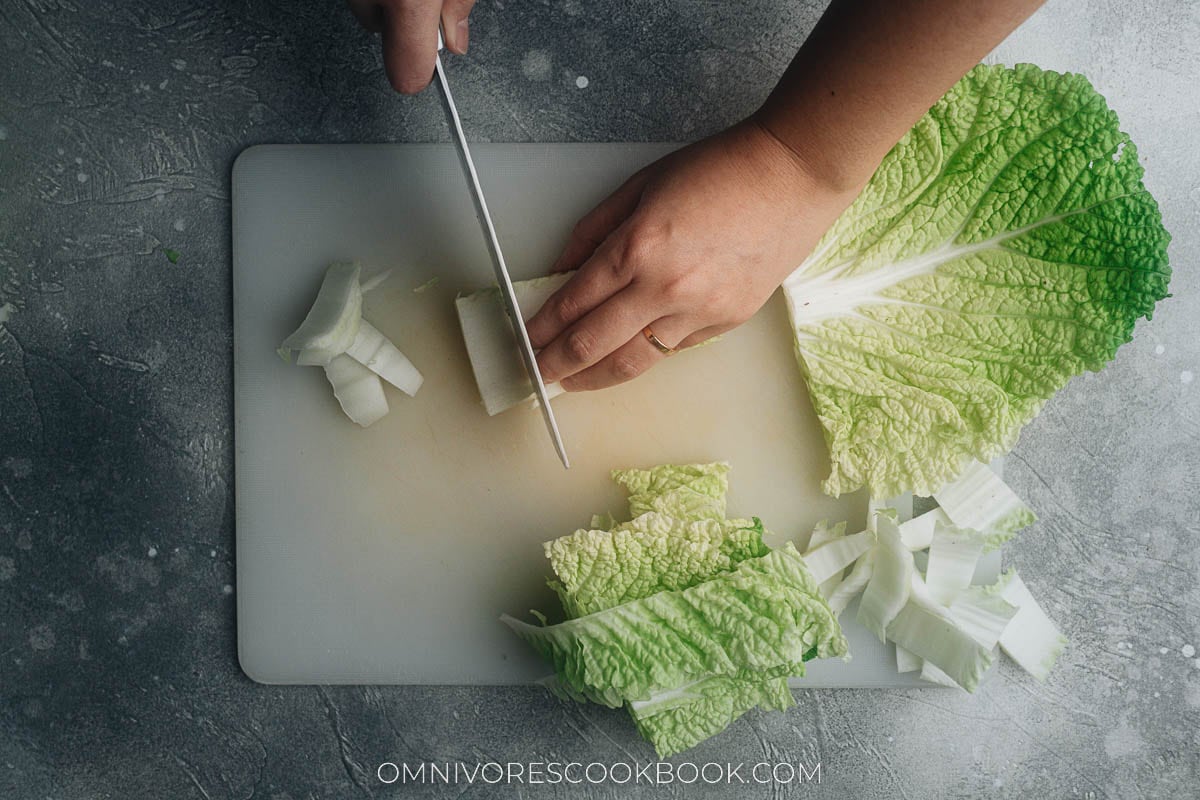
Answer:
[347, 0, 475, 95]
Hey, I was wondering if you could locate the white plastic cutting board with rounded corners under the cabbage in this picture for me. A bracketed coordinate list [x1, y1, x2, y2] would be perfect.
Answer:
[233, 144, 993, 686]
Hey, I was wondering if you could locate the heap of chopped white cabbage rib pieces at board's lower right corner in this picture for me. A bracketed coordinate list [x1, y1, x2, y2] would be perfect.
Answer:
[804, 464, 1066, 691]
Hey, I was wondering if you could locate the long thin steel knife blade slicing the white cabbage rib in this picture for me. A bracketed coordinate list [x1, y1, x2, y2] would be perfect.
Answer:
[433, 30, 571, 469]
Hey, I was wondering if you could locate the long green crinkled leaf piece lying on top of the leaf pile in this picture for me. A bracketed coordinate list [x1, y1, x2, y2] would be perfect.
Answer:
[504, 543, 847, 706]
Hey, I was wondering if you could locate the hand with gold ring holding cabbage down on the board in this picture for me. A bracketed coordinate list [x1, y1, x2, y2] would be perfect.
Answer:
[528, 119, 869, 391]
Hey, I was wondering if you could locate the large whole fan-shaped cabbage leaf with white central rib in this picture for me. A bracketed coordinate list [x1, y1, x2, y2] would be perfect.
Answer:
[784, 65, 1170, 497]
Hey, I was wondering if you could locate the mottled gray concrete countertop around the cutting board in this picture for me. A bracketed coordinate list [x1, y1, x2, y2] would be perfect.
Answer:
[0, 0, 1200, 800]
